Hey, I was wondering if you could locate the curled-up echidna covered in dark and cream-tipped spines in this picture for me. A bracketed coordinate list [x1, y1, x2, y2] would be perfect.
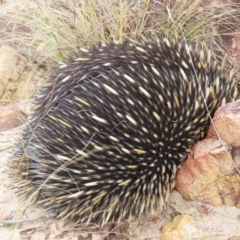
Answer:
[11, 38, 237, 224]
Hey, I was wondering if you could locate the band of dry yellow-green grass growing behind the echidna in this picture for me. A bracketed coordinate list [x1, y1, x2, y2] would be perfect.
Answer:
[0, 0, 240, 62]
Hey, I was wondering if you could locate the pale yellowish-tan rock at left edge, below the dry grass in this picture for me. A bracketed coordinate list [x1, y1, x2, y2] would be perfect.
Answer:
[0, 45, 48, 102]
